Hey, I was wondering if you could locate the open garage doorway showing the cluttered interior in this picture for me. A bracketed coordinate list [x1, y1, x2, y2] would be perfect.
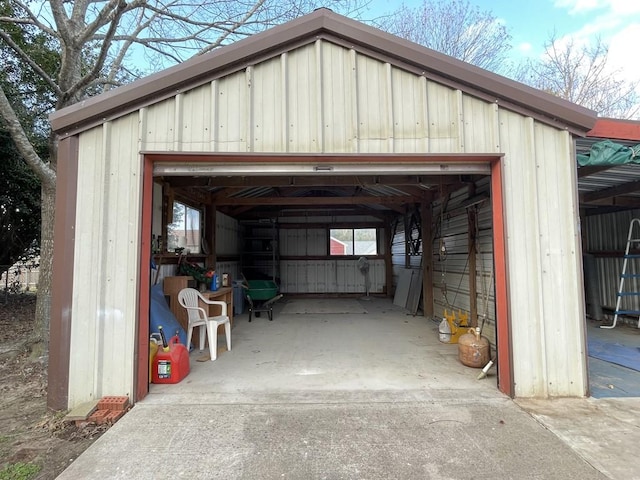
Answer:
[141, 155, 508, 400]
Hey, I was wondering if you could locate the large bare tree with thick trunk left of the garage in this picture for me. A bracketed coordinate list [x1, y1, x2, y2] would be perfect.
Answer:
[0, 0, 361, 355]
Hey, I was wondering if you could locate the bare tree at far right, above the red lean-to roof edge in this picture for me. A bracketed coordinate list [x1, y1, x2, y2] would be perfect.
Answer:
[518, 34, 640, 118]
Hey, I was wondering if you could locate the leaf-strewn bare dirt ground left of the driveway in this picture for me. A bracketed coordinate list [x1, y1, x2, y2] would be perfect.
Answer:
[0, 294, 108, 480]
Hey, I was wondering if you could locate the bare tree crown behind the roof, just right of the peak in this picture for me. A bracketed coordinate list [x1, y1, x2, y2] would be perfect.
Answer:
[376, 0, 511, 72]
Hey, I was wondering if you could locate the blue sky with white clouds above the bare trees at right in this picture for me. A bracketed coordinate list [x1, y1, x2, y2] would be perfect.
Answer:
[364, 0, 640, 80]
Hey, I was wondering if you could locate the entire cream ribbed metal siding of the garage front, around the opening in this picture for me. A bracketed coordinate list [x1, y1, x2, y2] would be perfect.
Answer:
[70, 40, 586, 406]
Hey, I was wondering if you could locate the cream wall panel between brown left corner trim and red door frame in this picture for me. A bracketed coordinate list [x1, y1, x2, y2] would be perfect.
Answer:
[69, 115, 141, 405]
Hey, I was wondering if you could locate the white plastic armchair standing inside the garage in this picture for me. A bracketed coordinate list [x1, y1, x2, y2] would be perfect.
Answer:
[178, 288, 231, 361]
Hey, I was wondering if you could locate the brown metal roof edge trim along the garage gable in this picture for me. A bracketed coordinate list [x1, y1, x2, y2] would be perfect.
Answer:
[50, 8, 596, 136]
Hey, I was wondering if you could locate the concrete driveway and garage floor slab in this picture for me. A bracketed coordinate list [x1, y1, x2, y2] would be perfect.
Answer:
[59, 299, 640, 480]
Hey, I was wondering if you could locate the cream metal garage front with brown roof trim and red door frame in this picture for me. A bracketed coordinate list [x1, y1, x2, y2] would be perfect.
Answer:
[49, 9, 596, 409]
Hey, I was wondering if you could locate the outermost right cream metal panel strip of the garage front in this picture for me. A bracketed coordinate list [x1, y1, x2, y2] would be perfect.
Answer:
[535, 123, 586, 396]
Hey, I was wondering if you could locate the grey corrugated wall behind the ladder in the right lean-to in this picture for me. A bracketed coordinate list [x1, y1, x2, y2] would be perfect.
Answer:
[582, 210, 640, 316]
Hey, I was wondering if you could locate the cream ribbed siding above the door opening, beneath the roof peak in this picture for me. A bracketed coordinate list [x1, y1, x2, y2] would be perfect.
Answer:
[138, 40, 484, 153]
